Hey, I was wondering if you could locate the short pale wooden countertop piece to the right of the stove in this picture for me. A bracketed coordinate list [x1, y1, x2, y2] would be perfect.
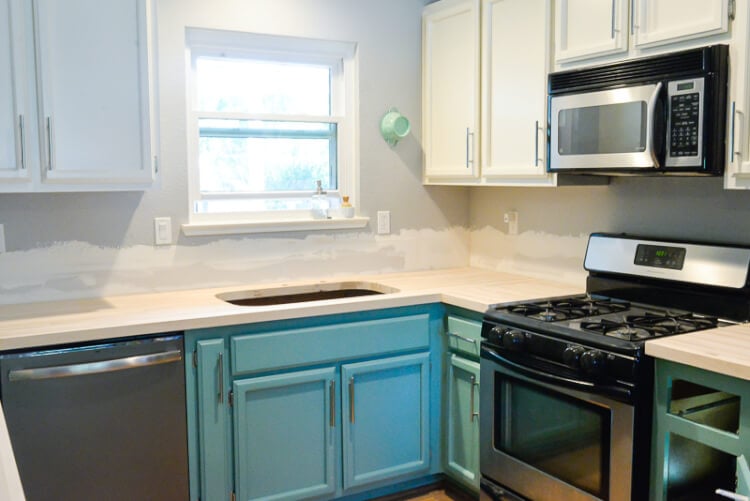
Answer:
[646, 324, 750, 380]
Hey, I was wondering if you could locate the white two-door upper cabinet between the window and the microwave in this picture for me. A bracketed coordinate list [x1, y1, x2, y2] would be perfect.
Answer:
[422, 0, 556, 186]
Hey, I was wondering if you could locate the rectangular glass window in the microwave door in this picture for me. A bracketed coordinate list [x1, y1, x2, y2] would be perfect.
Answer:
[557, 101, 648, 155]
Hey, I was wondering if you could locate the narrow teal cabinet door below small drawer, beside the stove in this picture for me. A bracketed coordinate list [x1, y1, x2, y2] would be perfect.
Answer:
[445, 355, 479, 490]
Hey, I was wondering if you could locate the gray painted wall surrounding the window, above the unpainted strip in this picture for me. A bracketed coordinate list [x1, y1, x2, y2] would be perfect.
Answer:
[0, 0, 469, 251]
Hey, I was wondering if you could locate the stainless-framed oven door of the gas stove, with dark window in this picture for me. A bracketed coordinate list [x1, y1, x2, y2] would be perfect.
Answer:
[479, 345, 634, 501]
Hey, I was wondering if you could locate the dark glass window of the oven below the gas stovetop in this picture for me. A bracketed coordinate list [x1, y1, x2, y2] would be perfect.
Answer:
[494, 373, 611, 500]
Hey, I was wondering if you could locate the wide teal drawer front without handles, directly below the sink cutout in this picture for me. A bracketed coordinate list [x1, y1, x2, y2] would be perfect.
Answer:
[231, 313, 430, 376]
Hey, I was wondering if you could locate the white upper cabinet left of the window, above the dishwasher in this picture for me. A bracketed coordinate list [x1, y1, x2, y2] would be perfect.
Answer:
[0, 0, 156, 192]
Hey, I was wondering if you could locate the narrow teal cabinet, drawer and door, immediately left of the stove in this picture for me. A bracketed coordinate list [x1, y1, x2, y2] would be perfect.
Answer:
[443, 310, 482, 493]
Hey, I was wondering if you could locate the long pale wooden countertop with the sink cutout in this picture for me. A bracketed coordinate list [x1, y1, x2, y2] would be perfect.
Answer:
[0, 268, 584, 351]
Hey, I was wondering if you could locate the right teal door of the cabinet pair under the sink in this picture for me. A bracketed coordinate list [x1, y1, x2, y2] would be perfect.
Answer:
[341, 353, 430, 489]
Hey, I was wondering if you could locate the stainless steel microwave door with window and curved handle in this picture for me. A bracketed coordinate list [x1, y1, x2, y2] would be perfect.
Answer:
[548, 83, 666, 173]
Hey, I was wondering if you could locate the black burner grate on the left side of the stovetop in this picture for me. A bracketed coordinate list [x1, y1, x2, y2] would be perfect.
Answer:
[507, 296, 630, 322]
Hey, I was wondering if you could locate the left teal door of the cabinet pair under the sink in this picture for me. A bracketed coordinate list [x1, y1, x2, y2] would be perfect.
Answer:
[235, 367, 339, 501]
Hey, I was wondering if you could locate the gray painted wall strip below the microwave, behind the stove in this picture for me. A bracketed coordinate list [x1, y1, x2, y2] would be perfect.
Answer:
[471, 177, 750, 245]
